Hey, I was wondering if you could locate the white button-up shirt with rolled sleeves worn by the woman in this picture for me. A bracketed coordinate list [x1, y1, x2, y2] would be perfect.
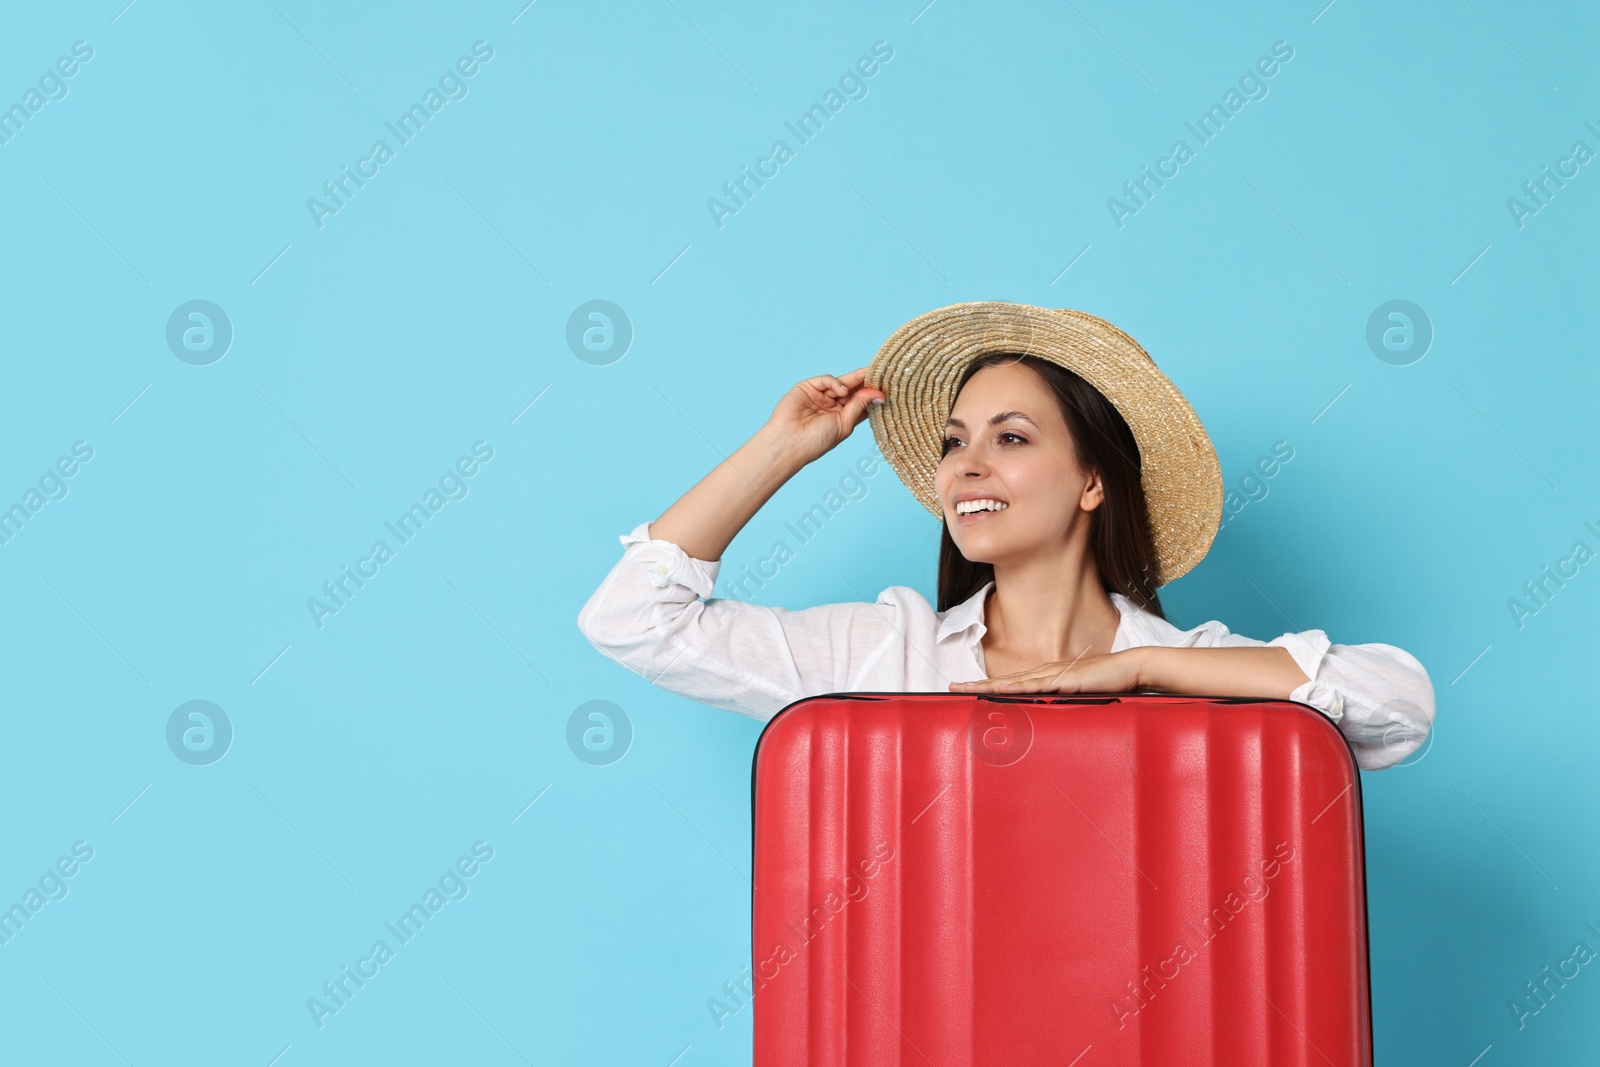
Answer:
[578, 523, 1434, 771]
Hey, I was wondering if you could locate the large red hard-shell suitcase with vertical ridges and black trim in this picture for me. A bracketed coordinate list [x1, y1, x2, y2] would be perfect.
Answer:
[750, 693, 1371, 1067]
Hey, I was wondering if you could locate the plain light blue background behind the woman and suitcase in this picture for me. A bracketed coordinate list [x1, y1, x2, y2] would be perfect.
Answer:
[0, 0, 1600, 1067]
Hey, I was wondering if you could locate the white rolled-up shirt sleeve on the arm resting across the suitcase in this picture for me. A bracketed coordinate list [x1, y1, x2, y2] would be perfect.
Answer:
[1189, 621, 1434, 771]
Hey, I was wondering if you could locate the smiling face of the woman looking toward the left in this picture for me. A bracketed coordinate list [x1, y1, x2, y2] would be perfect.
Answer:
[933, 363, 1104, 565]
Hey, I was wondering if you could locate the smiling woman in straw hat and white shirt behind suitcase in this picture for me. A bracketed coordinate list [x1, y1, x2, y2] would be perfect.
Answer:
[578, 301, 1434, 769]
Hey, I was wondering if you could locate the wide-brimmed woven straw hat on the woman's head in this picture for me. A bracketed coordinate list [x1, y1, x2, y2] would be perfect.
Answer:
[866, 301, 1222, 585]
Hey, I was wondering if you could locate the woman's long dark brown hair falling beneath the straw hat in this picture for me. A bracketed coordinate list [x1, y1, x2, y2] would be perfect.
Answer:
[938, 352, 1166, 619]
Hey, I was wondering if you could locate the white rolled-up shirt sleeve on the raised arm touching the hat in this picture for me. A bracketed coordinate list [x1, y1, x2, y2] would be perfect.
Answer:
[578, 523, 893, 721]
